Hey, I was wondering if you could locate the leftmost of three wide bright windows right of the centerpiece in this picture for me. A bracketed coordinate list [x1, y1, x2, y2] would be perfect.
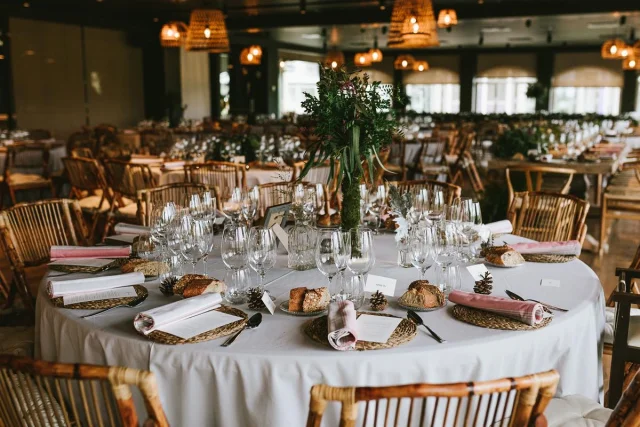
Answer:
[405, 84, 460, 113]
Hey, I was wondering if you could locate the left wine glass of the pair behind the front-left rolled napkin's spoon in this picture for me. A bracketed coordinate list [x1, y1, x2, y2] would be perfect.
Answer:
[220, 223, 249, 304]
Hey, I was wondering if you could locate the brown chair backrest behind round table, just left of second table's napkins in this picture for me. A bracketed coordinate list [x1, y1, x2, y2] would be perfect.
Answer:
[104, 160, 156, 199]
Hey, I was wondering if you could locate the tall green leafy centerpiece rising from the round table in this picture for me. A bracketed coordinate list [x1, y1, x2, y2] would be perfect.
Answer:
[300, 67, 399, 230]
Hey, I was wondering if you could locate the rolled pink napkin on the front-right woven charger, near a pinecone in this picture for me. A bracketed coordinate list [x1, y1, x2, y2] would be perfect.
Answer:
[449, 291, 544, 326]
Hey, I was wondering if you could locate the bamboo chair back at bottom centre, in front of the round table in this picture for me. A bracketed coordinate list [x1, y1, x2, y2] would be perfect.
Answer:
[307, 370, 560, 427]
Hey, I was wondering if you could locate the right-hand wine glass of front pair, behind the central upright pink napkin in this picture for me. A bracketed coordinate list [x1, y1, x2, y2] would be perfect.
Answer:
[346, 228, 376, 308]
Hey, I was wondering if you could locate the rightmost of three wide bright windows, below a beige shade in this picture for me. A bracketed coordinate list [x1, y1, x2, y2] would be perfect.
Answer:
[551, 87, 620, 114]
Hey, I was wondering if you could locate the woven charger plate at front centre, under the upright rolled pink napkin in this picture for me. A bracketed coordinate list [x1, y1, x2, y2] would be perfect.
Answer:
[303, 312, 418, 351]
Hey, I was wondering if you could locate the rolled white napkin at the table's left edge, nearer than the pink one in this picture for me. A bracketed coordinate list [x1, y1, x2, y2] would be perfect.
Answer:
[47, 272, 144, 298]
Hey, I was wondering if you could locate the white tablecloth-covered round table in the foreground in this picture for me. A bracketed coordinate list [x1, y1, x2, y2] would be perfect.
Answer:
[36, 234, 604, 427]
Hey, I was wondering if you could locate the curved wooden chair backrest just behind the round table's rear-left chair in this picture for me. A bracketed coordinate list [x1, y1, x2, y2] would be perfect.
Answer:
[184, 162, 247, 196]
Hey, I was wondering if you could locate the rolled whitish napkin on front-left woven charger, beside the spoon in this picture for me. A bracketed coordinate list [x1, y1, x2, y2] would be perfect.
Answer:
[133, 293, 222, 335]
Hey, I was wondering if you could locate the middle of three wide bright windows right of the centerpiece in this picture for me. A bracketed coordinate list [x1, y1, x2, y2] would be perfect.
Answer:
[473, 77, 536, 114]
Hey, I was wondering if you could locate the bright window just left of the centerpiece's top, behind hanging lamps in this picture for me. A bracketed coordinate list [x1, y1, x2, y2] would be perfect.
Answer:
[280, 61, 320, 114]
